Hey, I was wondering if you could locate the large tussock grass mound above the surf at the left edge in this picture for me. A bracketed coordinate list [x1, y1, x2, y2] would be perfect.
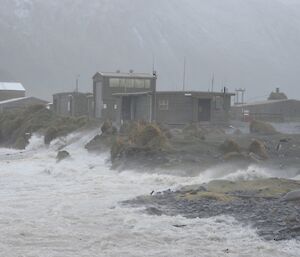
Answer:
[0, 105, 89, 149]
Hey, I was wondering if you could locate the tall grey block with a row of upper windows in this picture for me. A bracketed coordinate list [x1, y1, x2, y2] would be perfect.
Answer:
[93, 71, 156, 122]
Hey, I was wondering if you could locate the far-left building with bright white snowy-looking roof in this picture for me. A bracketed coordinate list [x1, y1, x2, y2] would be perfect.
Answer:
[0, 82, 25, 101]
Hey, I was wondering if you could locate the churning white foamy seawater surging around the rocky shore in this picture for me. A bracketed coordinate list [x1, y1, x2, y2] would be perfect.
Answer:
[0, 133, 300, 257]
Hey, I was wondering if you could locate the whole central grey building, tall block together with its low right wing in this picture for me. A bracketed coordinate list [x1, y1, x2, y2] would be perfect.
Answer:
[93, 72, 234, 126]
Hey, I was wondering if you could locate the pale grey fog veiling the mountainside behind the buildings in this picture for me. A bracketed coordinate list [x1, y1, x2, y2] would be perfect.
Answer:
[0, 0, 300, 100]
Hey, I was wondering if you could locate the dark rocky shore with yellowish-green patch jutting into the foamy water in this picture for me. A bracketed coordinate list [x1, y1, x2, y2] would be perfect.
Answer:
[124, 178, 300, 240]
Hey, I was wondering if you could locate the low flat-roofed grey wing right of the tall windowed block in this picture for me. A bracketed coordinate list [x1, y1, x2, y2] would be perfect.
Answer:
[155, 90, 234, 126]
